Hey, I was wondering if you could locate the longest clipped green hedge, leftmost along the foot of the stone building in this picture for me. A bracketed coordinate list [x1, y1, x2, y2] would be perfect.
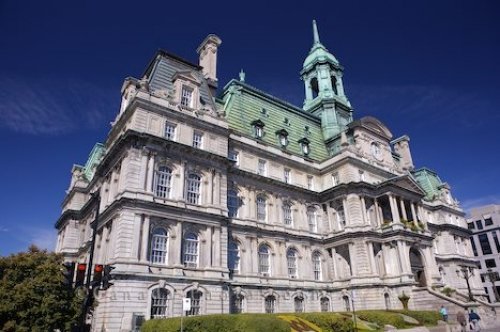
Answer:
[141, 314, 290, 332]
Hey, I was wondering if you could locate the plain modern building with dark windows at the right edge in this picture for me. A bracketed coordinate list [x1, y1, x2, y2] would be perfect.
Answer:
[467, 204, 500, 302]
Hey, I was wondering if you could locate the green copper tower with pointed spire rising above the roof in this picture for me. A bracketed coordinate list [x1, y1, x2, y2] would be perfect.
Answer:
[300, 20, 352, 141]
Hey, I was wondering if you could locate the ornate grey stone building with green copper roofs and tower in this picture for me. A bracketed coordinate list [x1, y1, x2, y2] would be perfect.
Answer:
[56, 23, 492, 331]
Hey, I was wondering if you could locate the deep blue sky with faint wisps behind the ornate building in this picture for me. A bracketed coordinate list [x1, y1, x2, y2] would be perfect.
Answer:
[0, 0, 500, 255]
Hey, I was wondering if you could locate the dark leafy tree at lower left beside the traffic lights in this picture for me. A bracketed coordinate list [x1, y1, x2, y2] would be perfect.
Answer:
[0, 246, 79, 332]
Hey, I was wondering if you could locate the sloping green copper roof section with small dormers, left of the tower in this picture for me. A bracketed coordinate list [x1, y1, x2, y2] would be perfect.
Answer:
[222, 80, 328, 161]
